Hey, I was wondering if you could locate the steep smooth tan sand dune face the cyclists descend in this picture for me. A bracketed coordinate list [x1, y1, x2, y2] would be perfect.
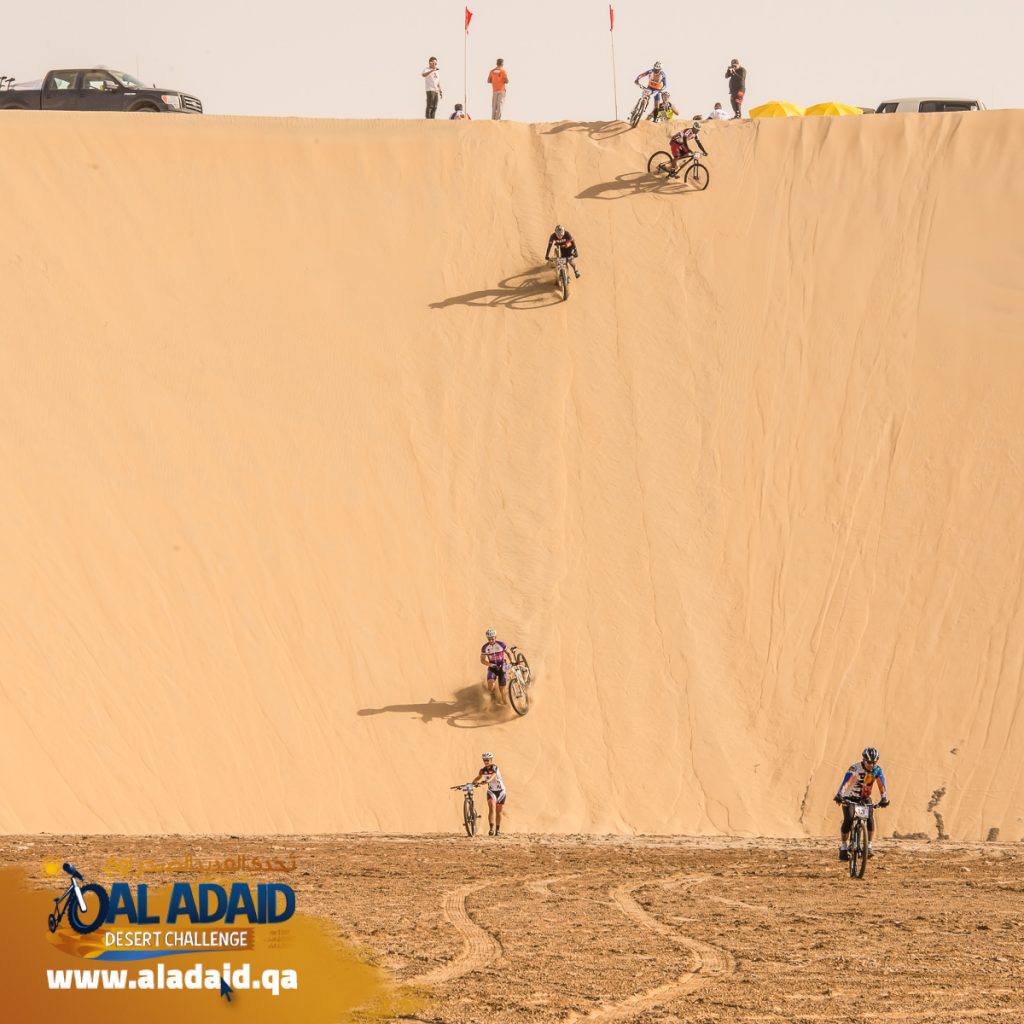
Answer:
[0, 113, 1024, 840]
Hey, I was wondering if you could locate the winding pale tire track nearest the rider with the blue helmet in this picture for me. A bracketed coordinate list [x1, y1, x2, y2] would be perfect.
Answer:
[566, 874, 736, 1024]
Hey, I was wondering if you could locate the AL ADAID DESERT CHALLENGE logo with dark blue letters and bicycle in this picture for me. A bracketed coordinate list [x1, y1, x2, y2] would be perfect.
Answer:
[47, 861, 295, 961]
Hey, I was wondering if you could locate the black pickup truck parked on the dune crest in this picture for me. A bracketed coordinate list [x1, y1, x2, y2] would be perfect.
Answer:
[0, 68, 203, 114]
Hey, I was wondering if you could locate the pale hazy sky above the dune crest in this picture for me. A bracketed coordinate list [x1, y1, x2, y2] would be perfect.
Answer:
[0, 0, 1024, 121]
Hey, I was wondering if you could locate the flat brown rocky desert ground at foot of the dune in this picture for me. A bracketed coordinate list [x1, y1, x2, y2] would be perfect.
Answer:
[0, 836, 1024, 1024]
